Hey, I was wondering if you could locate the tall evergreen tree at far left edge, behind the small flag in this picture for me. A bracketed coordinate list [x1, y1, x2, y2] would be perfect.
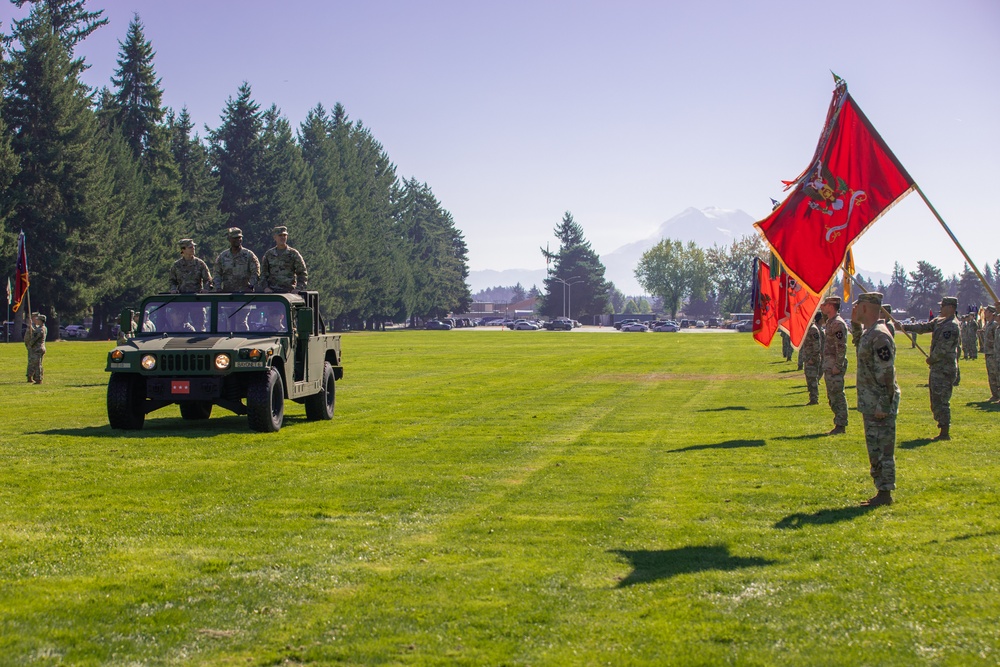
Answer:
[3, 4, 114, 333]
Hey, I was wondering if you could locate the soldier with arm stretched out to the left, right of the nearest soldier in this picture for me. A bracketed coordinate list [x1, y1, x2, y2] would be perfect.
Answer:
[903, 296, 961, 440]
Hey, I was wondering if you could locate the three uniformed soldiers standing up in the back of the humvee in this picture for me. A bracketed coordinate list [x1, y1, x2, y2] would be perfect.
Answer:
[169, 226, 309, 294]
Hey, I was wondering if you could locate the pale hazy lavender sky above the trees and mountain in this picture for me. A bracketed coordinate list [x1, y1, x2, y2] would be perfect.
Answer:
[0, 0, 1000, 280]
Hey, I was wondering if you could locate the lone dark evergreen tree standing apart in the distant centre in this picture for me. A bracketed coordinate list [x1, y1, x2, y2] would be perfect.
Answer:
[539, 211, 609, 320]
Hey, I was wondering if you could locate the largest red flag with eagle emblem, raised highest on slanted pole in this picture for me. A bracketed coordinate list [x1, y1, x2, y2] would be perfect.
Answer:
[755, 79, 914, 294]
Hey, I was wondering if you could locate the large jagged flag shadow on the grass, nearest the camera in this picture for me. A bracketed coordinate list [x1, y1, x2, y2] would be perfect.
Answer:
[608, 546, 777, 588]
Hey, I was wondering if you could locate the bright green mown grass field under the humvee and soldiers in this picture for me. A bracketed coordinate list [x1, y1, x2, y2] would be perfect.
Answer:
[0, 331, 1000, 666]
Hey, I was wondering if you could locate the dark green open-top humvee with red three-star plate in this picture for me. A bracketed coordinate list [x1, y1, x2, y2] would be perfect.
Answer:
[105, 291, 344, 432]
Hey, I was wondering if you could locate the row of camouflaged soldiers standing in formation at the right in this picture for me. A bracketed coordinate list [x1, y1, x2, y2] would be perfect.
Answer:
[786, 292, 1000, 506]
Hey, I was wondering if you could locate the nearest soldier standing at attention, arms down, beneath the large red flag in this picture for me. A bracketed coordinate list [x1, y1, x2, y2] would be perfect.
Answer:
[851, 292, 899, 507]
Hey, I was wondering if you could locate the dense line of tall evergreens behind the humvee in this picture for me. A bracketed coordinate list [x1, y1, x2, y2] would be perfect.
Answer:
[0, 0, 471, 337]
